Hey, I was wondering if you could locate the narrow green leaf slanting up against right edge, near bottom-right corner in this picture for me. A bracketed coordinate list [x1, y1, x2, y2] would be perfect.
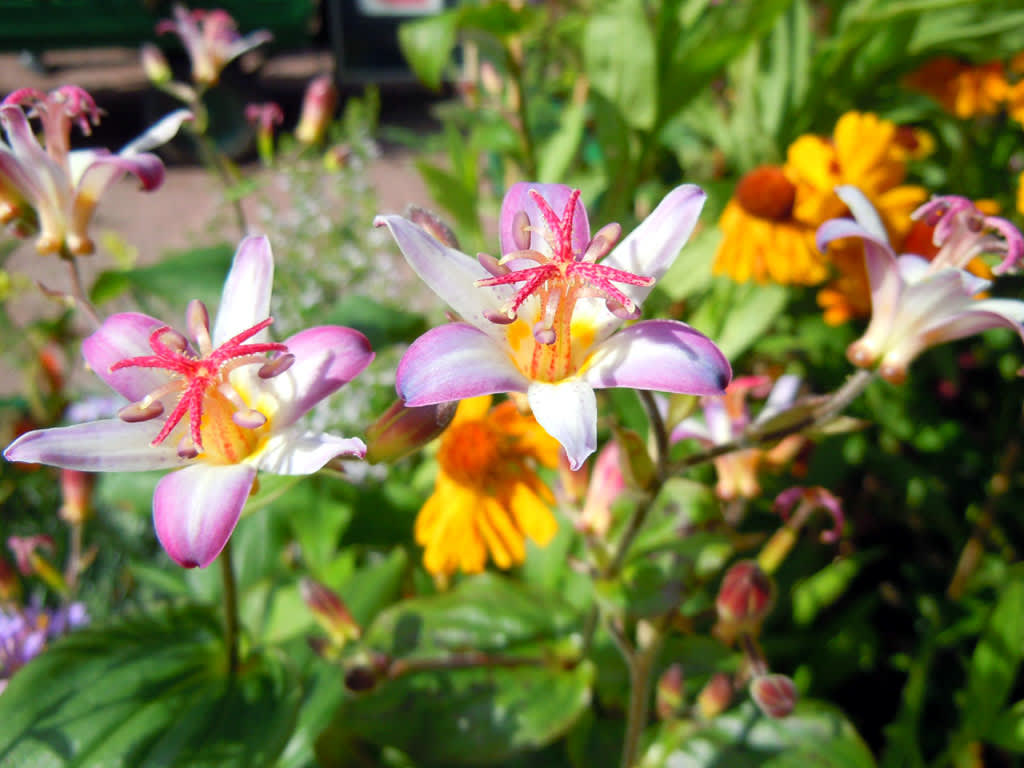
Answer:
[954, 577, 1024, 743]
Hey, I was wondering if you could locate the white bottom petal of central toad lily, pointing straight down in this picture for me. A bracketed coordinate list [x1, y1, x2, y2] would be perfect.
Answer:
[526, 379, 597, 469]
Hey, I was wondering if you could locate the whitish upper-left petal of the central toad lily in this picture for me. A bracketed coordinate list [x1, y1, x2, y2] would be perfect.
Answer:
[374, 216, 514, 339]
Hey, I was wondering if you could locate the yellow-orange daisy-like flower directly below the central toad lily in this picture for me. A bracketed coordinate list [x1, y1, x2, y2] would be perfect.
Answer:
[415, 396, 561, 575]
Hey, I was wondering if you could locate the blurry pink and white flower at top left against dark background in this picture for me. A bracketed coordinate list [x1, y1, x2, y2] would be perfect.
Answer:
[157, 5, 273, 86]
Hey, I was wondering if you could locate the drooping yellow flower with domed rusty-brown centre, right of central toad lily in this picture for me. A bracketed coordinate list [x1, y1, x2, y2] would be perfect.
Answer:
[712, 165, 827, 285]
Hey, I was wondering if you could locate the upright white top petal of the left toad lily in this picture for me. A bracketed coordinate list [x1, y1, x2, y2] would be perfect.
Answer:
[213, 236, 273, 347]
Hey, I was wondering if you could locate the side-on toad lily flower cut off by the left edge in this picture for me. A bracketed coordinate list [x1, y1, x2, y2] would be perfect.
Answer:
[0, 85, 191, 256]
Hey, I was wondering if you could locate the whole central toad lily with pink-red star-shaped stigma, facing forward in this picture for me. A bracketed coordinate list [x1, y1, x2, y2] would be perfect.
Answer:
[376, 182, 731, 469]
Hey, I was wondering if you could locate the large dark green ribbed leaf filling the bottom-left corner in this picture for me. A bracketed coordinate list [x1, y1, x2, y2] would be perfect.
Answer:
[0, 609, 301, 768]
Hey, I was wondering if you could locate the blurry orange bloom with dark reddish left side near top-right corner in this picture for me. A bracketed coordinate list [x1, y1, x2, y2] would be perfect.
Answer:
[906, 56, 1009, 120]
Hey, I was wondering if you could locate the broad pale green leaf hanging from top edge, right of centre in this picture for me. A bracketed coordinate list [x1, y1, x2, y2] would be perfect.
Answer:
[584, 0, 657, 130]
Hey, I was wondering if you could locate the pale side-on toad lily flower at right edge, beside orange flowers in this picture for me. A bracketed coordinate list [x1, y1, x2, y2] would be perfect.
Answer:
[817, 186, 1024, 384]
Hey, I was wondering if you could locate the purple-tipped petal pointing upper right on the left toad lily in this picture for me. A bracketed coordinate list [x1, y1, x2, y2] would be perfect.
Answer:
[263, 326, 374, 425]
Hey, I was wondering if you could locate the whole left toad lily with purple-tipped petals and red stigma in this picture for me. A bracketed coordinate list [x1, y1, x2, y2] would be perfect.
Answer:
[4, 238, 374, 567]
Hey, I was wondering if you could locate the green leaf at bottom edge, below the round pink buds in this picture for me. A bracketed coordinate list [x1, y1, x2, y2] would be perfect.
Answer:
[641, 701, 874, 768]
